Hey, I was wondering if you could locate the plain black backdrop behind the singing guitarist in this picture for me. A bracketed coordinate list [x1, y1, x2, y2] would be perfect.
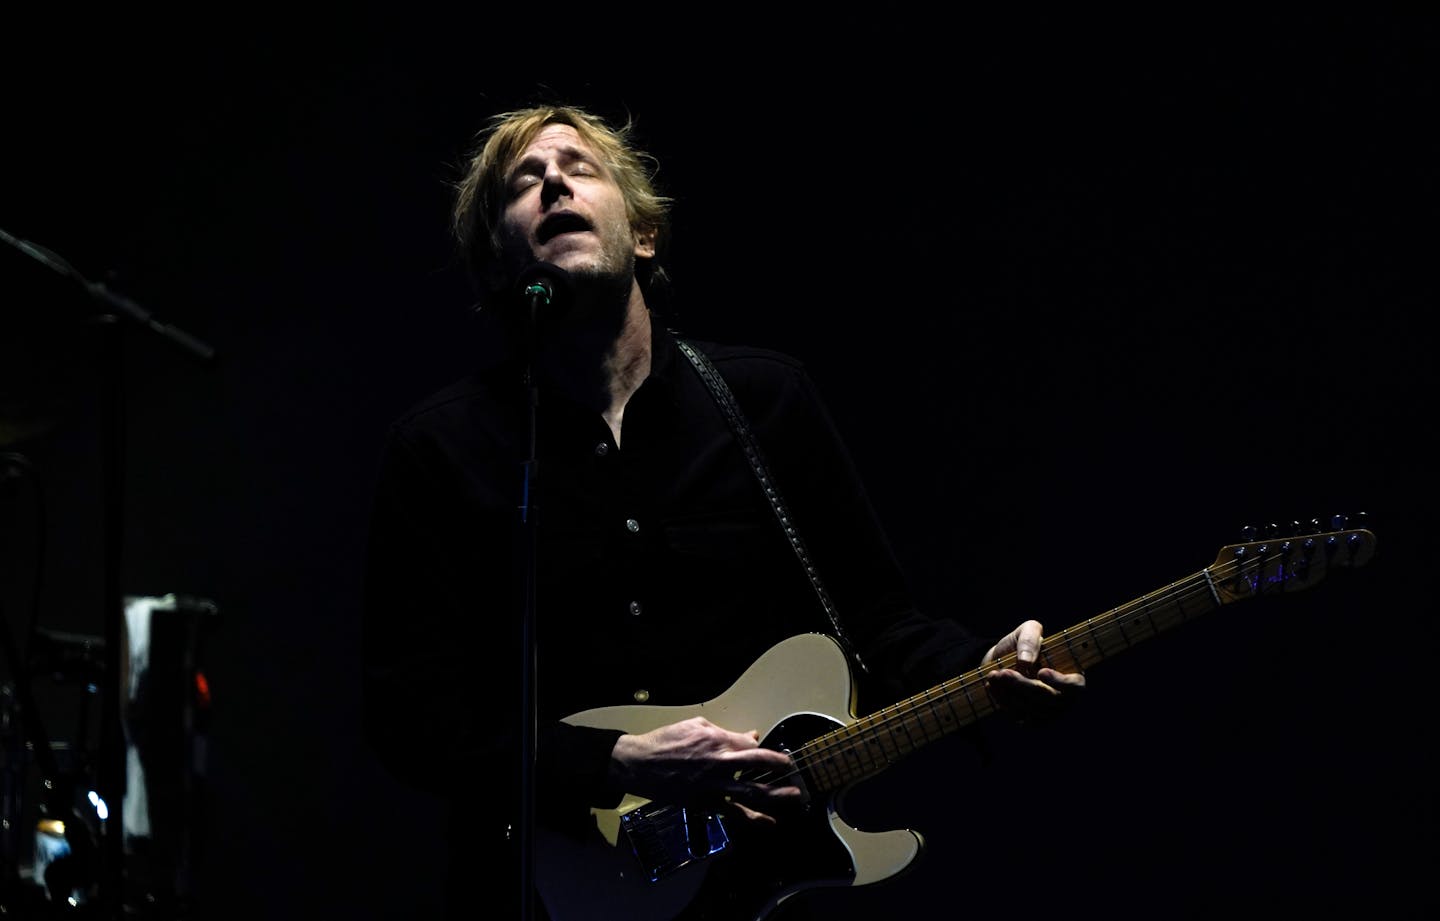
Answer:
[0, 7, 1437, 920]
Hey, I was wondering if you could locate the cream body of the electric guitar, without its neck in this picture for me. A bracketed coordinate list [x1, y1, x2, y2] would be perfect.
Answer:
[536, 633, 920, 921]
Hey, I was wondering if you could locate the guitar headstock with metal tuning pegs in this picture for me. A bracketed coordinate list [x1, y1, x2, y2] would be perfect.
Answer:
[1208, 515, 1375, 604]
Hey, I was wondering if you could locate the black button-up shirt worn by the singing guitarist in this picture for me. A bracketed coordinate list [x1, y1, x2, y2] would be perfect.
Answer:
[364, 324, 982, 828]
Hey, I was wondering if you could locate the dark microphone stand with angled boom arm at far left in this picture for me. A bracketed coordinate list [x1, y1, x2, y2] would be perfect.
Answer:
[0, 224, 215, 921]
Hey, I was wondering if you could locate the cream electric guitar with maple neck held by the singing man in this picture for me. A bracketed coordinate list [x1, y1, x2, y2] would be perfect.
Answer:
[534, 528, 1375, 921]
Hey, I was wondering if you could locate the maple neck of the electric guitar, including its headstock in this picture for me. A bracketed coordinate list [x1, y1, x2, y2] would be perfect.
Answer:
[792, 530, 1375, 793]
